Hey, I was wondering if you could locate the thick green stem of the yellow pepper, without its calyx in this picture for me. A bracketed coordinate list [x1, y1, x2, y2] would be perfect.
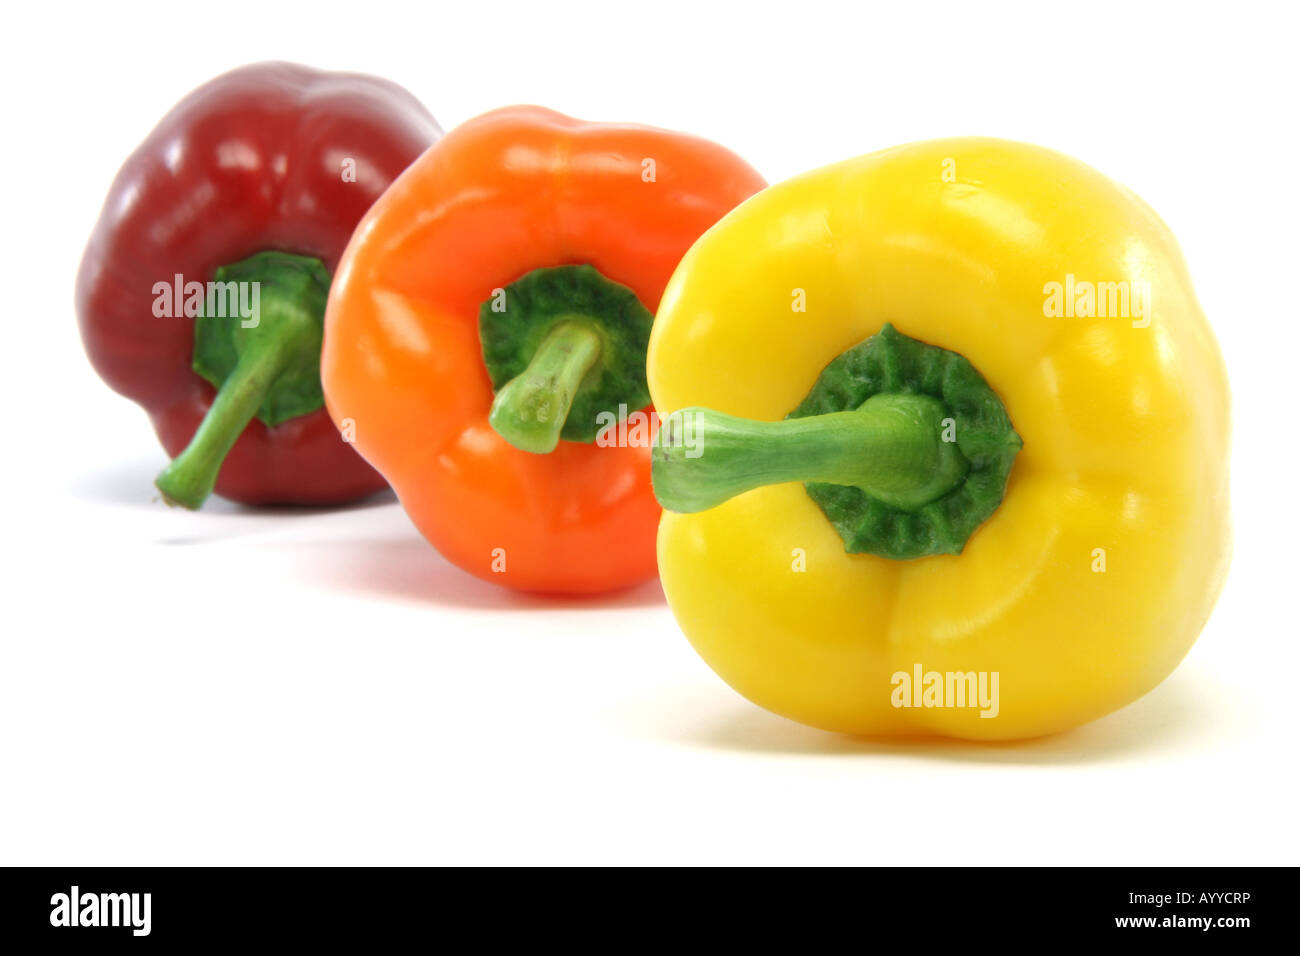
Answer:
[653, 394, 969, 512]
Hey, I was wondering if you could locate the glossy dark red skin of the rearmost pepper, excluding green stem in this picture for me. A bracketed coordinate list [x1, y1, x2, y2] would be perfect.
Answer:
[77, 62, 441, 505]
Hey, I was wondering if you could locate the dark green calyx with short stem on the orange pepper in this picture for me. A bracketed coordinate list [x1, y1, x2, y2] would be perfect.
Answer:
[478, 265, 654, 454]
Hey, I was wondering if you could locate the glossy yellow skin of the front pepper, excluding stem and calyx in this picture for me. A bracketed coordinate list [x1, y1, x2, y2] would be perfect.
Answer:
[649, 139, 1230, 739]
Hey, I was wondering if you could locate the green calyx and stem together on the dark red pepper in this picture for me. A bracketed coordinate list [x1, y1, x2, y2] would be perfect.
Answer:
[155, 252, 330, 509]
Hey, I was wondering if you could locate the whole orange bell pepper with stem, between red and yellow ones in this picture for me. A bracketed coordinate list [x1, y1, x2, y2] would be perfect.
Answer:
[321, 107, 764, 594]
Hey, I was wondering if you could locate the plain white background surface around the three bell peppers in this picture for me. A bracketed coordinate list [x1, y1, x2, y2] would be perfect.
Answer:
[0, 0, 1300, 865]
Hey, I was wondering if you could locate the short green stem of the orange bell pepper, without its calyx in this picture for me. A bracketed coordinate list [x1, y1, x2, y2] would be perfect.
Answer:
[488, 320, 601, 455]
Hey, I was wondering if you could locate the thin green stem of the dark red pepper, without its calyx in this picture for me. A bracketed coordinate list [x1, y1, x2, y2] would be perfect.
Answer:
[155, 325, 302, 510]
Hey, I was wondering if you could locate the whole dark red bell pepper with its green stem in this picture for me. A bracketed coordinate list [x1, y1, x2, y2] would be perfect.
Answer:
[77, 62, 441, 509]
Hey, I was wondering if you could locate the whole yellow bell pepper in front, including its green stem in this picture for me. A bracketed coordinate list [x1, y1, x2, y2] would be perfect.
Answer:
[649, 139, 1230, 739]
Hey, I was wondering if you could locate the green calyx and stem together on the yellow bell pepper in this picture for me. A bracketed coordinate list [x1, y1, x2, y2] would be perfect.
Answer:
[653, 325, 1021, 561]
